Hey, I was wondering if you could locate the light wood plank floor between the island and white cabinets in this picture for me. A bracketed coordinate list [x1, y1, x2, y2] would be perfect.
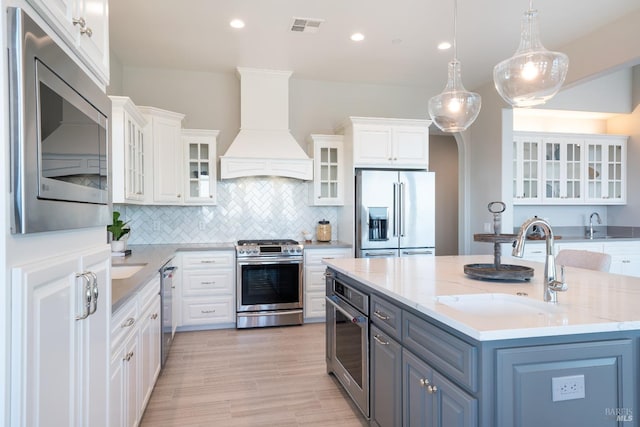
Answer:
[141, 323, 367, 427]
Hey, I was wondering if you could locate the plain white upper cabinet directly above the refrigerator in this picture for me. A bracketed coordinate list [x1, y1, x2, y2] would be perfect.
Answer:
[344, 117, 431, 169]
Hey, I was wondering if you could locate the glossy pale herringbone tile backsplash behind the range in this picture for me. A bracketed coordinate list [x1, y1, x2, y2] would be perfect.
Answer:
[114, 177, 338, 245]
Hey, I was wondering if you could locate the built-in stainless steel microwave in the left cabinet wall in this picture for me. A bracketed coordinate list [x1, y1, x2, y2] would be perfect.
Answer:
[7, 8, 111, 234]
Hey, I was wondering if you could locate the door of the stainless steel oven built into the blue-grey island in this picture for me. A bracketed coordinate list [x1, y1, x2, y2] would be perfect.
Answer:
[326, 295, 369, 418]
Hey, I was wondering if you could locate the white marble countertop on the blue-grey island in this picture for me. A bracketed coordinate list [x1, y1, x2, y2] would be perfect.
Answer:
[324, 255, 640, 341]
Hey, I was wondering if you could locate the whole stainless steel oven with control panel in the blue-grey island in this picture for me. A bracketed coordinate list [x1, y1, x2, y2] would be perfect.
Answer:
[326, 273, 369, 418]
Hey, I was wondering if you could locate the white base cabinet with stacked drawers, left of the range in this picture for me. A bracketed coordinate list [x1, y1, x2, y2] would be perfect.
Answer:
[180, 251, 236, 329]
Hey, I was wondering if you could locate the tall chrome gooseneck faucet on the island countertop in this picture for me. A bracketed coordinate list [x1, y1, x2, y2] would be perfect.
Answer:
[512, 218, 568, 304]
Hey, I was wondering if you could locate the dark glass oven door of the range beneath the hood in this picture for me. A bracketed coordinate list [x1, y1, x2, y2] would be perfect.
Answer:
[237, 257, 302, 312]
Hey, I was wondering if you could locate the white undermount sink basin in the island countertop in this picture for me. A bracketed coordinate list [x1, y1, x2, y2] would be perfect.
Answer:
[436, 294, 559, 317]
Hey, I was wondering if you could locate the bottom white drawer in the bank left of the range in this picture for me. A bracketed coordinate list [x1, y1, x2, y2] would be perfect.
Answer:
[182, 297, 236, 326]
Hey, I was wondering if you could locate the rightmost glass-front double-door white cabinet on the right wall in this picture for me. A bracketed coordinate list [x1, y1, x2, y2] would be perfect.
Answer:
[584, 135, 627, 204]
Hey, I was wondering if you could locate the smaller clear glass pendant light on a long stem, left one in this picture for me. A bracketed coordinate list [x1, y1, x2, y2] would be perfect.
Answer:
[429, 0, 482, 132]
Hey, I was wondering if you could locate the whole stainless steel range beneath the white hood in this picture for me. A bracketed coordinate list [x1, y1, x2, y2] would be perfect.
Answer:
[236, 240, 303, 328]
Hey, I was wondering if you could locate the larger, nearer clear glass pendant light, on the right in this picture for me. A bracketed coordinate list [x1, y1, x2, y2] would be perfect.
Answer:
[493, 0, 569, 107]
